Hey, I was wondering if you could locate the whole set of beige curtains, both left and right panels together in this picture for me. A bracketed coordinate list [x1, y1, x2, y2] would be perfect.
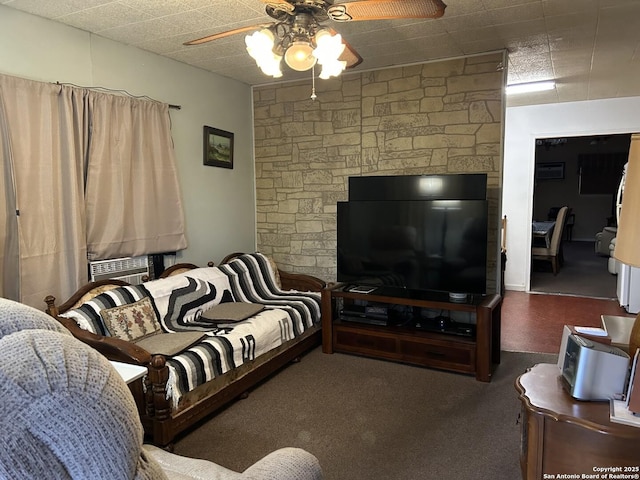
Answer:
[0, 75, 186, 309]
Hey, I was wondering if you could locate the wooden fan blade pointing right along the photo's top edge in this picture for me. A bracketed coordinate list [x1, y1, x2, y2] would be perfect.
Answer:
[327, 0, 447, 22]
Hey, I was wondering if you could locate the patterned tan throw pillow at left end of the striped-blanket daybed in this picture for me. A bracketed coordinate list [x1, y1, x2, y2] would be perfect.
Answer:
[100, 297, 162, 341]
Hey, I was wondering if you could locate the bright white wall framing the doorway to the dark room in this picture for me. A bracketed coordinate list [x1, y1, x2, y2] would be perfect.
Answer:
[502, 97, 640, 291]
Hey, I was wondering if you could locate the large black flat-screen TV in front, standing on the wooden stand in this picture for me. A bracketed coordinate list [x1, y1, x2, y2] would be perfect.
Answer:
[337, 200, 488, 294]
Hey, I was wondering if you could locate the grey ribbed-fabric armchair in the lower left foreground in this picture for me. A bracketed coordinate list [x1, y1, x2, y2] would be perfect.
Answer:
[0, 298, 322, 480]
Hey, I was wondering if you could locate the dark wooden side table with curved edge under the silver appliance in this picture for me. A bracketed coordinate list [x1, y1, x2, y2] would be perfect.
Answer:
[515, 363, 640, 480]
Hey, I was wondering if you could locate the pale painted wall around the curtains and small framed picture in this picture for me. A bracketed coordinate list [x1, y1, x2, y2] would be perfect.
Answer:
[0, 5, 256, 265]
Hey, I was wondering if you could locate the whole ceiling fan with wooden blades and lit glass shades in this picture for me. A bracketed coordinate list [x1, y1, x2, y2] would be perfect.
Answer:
[185, 0, 446, 79]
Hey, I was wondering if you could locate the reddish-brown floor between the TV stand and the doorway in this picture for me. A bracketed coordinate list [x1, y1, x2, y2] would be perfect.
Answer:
[501, 290, 635, 353]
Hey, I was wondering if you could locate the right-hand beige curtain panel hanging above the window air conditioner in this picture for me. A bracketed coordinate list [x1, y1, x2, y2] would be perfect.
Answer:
[86, 92, 187, 260]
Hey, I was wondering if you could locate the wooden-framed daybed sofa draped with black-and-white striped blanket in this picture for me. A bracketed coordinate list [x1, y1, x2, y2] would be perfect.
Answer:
[45, 253, 325, 448]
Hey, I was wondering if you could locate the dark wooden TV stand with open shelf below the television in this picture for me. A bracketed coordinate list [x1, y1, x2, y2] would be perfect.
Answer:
[322, 284, 502, 382]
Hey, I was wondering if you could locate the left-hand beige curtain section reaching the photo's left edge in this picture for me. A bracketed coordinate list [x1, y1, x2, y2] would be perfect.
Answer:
[0, 75, 87, 309]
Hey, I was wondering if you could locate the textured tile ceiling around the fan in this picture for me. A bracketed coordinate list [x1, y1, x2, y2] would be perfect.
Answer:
[5, 0, 640, 105]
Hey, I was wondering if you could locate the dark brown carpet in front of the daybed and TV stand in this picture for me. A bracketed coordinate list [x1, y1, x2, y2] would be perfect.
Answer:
[175, 348, 556, 480]
